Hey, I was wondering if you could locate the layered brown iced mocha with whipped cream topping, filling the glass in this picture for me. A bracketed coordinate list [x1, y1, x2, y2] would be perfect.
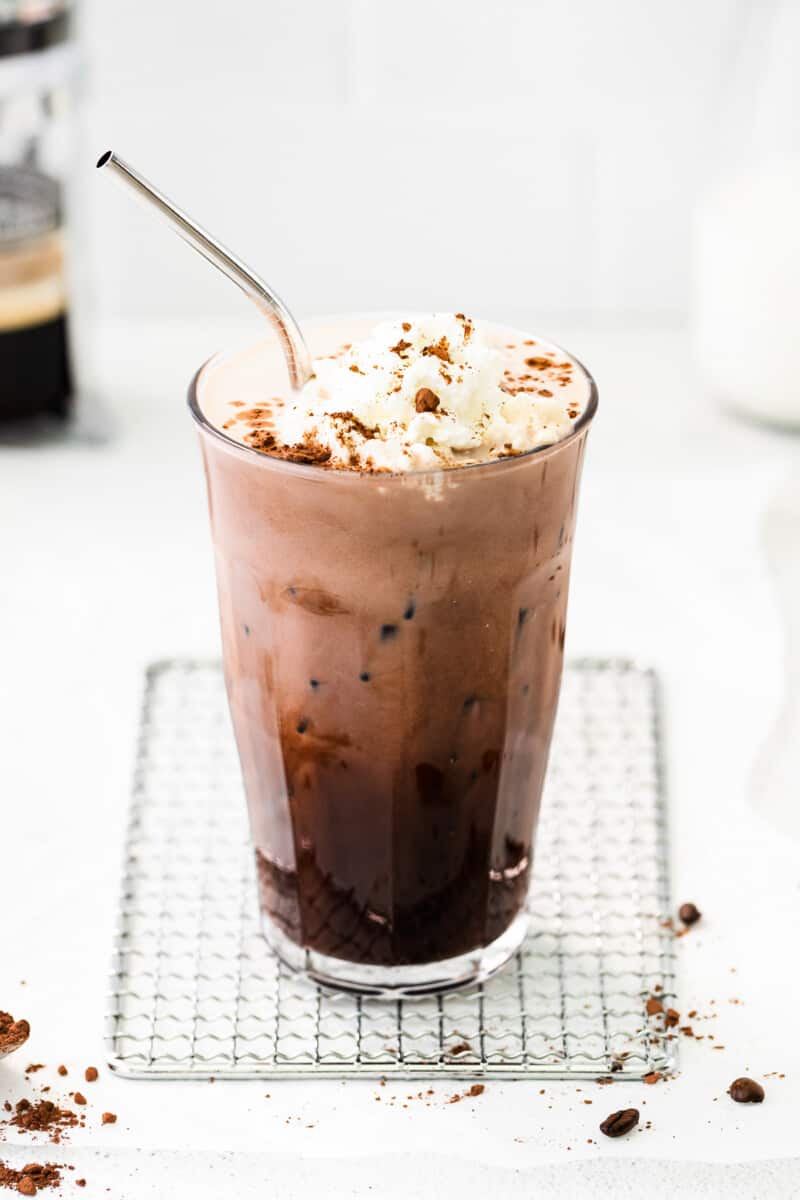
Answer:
[191, 314, 595, 992]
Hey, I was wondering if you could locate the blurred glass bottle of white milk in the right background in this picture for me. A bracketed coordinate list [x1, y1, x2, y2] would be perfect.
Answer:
[693, 0, 800, 427]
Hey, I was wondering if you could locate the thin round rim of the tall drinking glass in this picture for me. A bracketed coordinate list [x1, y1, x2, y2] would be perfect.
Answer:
[186, 338, 599, 484]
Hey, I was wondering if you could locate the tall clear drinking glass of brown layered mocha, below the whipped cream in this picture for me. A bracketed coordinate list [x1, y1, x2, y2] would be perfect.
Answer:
[190, 316, 596, 996]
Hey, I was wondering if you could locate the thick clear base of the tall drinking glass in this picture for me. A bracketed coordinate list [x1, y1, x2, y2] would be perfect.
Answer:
[261, 911, 528, 1000]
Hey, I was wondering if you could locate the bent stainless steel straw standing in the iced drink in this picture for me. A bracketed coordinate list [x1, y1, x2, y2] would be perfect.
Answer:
[97, 150, 312, 390]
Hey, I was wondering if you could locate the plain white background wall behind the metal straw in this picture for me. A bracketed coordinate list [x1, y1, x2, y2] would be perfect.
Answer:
[84, 0, 744, 323]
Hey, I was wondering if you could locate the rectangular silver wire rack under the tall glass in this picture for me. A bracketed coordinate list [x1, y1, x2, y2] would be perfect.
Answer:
[107, 660, 676, 1079]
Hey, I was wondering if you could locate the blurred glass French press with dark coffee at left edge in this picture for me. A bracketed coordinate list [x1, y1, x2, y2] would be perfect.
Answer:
[0, 0, 89, 436]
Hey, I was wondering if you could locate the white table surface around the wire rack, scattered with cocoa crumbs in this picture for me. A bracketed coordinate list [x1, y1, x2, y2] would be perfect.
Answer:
[0, 320, 800, 1200]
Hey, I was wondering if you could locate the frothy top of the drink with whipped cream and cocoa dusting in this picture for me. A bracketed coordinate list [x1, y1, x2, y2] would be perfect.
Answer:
[198, 313, 590, 472]
